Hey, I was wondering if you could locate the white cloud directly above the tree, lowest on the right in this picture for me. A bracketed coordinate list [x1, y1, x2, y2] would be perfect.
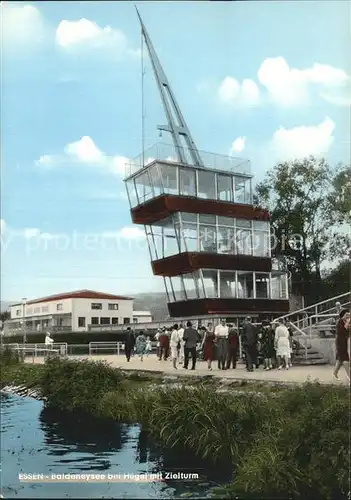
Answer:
[271, 117, 335, 160]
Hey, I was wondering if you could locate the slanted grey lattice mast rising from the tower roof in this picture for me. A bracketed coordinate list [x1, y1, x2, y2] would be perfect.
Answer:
[135, 7, 204, 167]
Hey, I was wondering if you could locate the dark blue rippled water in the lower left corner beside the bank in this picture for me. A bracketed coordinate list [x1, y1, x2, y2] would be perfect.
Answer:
[0, 393, 231, 498]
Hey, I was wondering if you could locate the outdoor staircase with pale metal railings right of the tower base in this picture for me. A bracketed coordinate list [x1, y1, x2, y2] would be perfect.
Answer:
[278, 292, 351, 365]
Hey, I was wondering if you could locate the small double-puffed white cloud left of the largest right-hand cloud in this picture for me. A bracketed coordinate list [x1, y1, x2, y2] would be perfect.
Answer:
[218, 76, 260, 106]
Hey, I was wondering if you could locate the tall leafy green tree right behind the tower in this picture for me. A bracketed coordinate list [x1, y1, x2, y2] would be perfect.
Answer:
[255, 156, 348, 301]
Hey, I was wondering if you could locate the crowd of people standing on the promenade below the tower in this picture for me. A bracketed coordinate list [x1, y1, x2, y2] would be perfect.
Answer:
[125, 318, 302, 372]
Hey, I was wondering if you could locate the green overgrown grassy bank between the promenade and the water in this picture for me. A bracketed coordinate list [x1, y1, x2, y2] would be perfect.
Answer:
[2, 359, 350, 499]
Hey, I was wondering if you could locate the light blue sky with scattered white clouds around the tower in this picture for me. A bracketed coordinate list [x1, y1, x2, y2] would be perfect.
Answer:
[1, 0, 351, 301]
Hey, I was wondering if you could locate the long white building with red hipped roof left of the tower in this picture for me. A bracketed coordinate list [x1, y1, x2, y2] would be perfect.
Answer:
[6, 290, 152, 333]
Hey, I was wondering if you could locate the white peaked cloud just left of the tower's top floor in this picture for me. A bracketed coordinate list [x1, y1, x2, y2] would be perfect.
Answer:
[35, 136, 131, 177]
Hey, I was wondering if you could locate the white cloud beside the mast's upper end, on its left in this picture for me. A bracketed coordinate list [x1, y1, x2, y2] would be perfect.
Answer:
[56, 18, 140, 58]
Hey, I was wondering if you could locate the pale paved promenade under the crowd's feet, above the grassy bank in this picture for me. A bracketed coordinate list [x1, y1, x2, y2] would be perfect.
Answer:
[26, 355, 348, 385]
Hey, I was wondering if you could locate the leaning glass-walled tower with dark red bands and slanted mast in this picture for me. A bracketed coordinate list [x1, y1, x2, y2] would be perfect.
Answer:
[125, 12, 289, 320]
